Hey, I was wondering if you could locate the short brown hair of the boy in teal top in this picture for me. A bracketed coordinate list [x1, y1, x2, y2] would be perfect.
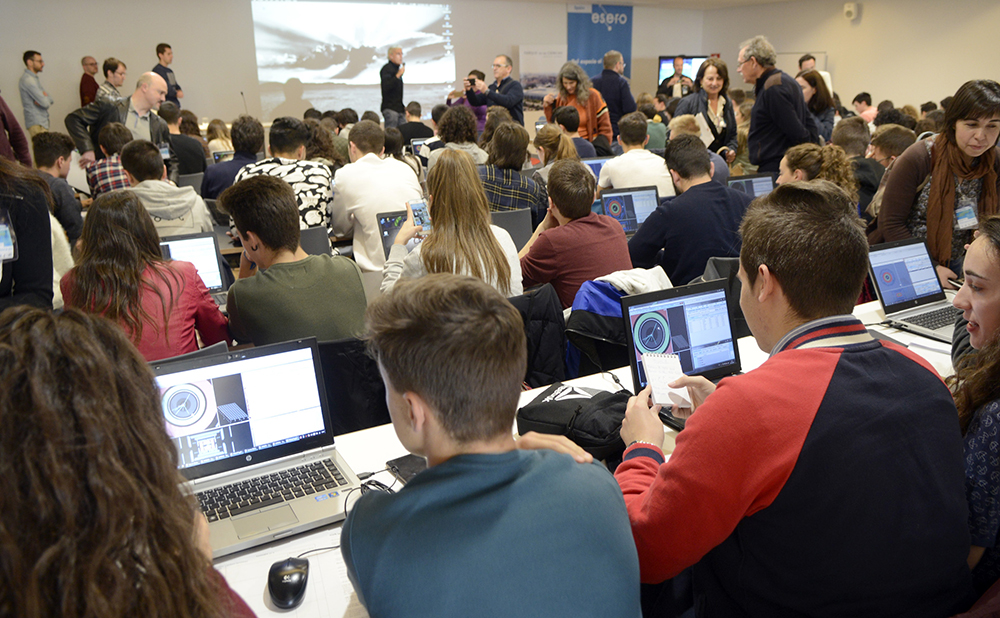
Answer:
[365, 273, 527, 443]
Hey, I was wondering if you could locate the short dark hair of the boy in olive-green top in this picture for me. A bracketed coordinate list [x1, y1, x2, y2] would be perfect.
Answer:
[218, 174, 299, 252]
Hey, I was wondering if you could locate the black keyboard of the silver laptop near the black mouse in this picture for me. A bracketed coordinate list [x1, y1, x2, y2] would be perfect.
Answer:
[196, 459, 347, 521]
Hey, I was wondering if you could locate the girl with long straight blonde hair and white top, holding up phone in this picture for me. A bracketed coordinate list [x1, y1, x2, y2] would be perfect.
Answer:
[382, 148, 530, 296]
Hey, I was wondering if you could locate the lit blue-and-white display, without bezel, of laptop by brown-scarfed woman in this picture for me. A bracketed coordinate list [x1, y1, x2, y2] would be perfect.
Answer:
[869, 243, 941, 305]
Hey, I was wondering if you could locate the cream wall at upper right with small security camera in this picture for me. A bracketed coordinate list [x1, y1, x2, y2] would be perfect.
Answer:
[704, 0, 1000, 107]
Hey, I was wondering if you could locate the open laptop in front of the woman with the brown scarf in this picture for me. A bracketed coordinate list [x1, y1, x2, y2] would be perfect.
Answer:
[868, 238, 962, 343]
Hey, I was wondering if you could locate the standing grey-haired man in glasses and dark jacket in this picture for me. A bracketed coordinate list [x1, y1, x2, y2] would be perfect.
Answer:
[736, 36, 819, 172]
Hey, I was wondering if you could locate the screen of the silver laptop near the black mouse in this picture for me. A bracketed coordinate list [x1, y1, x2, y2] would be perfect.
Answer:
[153, 340, 333, 478]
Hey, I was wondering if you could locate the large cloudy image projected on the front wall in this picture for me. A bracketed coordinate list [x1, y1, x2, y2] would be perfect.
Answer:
[251, 0, 456, 120]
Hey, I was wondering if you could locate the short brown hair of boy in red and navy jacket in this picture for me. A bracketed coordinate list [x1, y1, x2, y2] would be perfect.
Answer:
[740, 180, 868, 320]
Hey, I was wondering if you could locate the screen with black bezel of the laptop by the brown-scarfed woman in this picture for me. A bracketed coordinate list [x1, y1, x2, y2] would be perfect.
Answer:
[868, 238, 944, 313]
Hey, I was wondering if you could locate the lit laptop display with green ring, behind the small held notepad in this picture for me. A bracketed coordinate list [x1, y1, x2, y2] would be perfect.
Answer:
[628, 289, 736, 386]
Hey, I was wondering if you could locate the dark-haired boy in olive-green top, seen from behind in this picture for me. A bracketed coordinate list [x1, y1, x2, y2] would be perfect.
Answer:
[219, 175, 367, 345]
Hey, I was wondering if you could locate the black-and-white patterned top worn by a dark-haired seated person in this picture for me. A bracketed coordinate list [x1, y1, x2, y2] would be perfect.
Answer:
[234, 157, 333, 230]
